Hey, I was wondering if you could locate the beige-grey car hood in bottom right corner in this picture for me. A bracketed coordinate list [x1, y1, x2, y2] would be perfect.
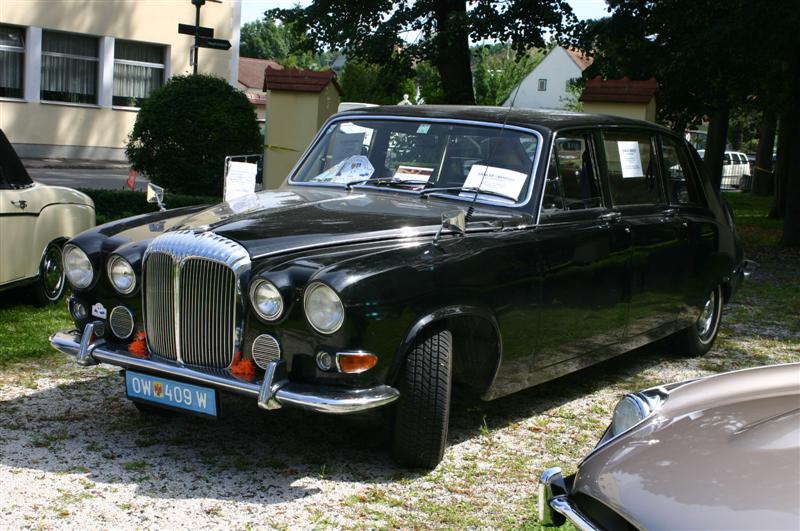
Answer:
[574, 364, 800, 529]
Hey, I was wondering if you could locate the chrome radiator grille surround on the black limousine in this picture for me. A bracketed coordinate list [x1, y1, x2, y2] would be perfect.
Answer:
[141, 230, 251, 369]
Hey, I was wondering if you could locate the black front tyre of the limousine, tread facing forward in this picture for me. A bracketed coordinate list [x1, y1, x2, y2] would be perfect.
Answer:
[393, 328, 453, 469]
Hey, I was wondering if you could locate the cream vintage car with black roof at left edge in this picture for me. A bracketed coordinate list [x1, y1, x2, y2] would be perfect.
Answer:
[0, 131, 94, 305]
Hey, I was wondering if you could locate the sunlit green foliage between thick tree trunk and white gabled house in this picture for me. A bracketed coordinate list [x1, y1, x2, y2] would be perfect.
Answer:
[472, 45, 544, 105]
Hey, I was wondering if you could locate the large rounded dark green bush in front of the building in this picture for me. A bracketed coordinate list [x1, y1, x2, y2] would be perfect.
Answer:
[125, 74, 263, 196]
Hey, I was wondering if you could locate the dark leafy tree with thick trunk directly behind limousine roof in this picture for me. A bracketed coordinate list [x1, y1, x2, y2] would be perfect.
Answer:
[266, 0, 575, 104]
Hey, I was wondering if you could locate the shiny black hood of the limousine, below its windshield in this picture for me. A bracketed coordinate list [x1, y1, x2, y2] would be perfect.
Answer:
[167, 186, 530, 258]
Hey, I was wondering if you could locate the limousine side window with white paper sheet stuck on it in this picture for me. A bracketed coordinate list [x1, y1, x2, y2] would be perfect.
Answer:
[603, 132, 663, 206]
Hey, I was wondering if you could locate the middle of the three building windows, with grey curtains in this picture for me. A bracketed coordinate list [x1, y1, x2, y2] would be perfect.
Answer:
[41, 31, 99, 103]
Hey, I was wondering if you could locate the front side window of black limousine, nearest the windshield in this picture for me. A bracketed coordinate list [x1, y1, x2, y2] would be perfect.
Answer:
[542, 133, 603, 211]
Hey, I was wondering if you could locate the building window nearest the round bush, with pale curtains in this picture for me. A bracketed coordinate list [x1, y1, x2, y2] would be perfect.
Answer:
[113, 40, 165, 107]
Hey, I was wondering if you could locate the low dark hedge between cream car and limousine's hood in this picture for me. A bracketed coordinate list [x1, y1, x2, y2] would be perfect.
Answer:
[81, 188, 220, 225]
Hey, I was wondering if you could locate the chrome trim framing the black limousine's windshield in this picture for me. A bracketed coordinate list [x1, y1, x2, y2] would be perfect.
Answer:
[286, 116, 544, 209]
